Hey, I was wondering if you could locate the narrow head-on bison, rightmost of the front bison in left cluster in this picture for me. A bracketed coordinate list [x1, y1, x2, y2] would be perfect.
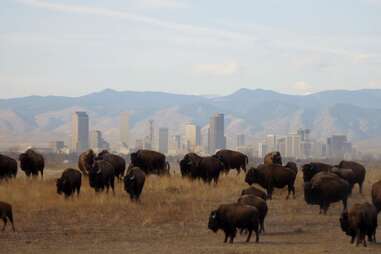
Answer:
[124, 167, 146, 201]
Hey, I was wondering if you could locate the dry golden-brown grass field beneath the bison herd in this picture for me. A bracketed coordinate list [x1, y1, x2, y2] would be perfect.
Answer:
[0, 166, 381, 254]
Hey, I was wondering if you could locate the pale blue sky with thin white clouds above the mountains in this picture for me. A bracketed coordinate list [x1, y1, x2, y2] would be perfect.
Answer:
[0, 0, 381, 98]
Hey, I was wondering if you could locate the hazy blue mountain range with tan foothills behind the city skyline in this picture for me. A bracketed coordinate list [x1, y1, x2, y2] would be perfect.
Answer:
[0, 88, 381, 151]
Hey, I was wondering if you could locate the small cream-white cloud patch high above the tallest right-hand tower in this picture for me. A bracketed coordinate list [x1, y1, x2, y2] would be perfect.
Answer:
[193, 61, 240, 76]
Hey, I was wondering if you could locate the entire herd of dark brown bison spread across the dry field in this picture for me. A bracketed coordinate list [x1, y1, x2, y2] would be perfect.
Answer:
[0, 149, 381, 246]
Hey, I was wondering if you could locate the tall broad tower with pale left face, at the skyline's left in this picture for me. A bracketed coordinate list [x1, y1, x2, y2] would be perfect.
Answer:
[72, 112, 89, 153]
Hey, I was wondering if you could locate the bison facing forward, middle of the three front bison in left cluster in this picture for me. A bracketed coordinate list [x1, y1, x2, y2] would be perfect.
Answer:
[89, 160, 115, 194]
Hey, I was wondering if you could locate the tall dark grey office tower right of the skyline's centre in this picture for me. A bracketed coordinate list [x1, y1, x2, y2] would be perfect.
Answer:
[208, 114, 226, 154]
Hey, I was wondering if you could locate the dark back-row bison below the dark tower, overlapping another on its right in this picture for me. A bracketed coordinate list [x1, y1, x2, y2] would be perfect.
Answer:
[180, 154, 224, 184]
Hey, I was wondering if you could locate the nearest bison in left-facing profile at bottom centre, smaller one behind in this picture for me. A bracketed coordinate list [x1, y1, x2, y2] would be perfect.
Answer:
[208, 203, 259, 243]
